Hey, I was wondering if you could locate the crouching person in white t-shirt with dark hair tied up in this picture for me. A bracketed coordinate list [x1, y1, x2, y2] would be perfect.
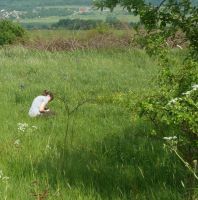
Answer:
[28, 90, 54, 117]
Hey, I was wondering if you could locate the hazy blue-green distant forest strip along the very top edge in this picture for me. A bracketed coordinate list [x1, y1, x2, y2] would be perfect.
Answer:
[0, 0, 198, 10]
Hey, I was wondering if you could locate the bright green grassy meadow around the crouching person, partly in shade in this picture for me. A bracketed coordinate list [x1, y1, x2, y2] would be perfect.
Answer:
[0, 38, 189, 200]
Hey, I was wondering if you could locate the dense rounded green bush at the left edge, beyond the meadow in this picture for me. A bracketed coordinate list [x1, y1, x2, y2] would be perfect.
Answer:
[0, 20, 25, 45]
